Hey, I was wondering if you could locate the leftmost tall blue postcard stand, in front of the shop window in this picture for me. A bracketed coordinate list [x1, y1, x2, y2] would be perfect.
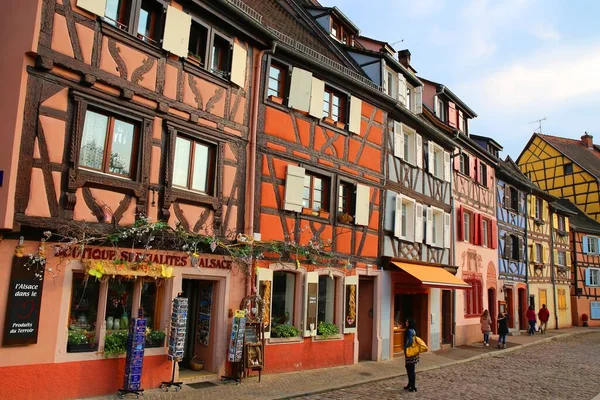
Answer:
[118, 307, 146, 398]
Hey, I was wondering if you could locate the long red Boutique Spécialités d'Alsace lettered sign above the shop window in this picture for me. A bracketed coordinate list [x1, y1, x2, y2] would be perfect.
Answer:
[54, 246, 233, 269]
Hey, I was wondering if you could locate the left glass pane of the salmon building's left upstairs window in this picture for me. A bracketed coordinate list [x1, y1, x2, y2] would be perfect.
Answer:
[79, 111, 108, 169]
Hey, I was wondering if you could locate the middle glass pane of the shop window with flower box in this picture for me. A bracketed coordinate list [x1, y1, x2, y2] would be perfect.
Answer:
[106, 279, 133, 332]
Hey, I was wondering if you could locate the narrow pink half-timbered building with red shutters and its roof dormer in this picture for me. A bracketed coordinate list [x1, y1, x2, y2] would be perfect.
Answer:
[421, 78, 498, 345]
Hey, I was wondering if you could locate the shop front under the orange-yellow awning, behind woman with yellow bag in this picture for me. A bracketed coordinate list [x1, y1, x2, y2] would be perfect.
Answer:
[389, 261, 470, 357]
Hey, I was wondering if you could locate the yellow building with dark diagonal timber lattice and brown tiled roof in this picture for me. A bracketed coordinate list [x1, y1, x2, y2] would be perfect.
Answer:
[517, 132, 600, 222]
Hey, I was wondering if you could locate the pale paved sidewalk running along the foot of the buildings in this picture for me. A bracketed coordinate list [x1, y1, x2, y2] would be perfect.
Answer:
[84, 328, 598, 400]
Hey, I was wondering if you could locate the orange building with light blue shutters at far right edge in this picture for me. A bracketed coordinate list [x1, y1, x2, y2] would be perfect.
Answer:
[560, 199, 600, 326]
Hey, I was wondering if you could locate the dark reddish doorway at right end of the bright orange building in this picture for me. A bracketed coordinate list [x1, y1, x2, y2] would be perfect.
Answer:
[357, 278, 375, 360]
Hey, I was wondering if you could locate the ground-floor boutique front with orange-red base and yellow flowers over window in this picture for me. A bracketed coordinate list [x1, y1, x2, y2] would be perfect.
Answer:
[0, 240, 246, 399]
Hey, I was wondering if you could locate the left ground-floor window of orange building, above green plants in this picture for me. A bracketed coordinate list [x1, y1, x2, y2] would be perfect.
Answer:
[271, 271, 296, 326]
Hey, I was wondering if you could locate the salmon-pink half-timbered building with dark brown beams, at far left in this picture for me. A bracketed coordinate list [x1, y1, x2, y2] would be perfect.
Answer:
[0, 0, 268, 399]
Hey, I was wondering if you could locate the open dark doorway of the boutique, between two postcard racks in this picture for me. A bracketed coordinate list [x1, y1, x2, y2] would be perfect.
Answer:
[179, 279, 218, 372]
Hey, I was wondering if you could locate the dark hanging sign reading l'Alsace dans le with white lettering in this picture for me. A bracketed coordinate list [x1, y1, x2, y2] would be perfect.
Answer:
[2, 256, 44, 346]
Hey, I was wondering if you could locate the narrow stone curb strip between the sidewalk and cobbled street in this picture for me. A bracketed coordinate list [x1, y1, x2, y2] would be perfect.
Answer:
[271, 330, 600, 400]
